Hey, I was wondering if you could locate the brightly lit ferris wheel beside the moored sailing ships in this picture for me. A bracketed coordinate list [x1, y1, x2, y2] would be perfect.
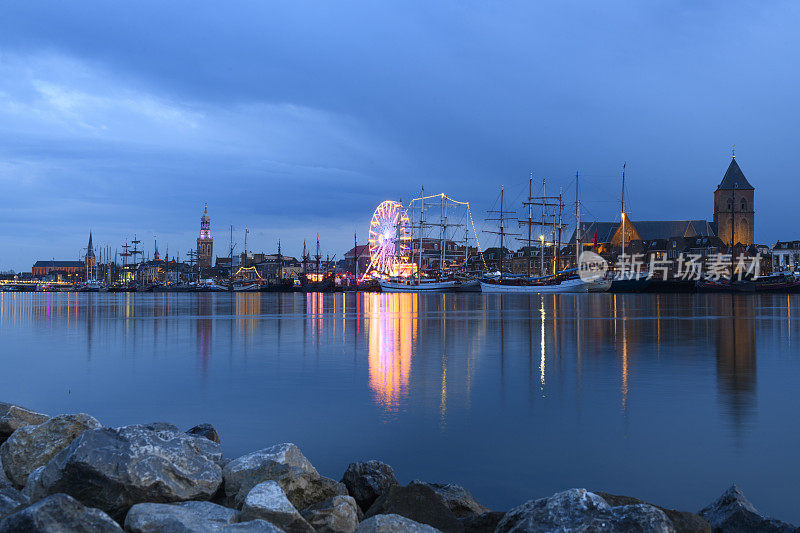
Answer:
[368, 200, 415, 276]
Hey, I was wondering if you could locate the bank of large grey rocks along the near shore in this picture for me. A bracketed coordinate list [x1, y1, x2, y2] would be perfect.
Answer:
[0, 402, 798, 533]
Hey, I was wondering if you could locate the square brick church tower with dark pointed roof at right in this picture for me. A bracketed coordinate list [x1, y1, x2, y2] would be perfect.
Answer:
[714, 155, 755, 245]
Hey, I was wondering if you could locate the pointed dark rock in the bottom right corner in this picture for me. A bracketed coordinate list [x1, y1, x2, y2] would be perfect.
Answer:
[700, 485, 796, 533]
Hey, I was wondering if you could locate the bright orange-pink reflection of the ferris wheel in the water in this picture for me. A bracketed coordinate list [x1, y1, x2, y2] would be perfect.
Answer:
[364, 293, 418, 414]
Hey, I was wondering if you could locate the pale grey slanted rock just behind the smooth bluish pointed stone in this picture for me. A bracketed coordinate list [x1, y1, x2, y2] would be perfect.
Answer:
[222, 443, 319, 502]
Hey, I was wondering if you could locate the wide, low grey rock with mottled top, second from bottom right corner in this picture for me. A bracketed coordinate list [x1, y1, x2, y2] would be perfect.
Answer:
[496, 489, 675, 533]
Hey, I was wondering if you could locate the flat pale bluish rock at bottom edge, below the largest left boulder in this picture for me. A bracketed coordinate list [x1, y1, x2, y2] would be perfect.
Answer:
[125, 502, 239, 533]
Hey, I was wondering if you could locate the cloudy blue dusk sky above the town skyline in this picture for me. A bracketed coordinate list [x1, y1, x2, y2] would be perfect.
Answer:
[0, 0, 800, 271]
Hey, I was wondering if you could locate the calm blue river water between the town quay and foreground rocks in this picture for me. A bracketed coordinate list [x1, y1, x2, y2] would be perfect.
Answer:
[0, 293, 800, 523]
